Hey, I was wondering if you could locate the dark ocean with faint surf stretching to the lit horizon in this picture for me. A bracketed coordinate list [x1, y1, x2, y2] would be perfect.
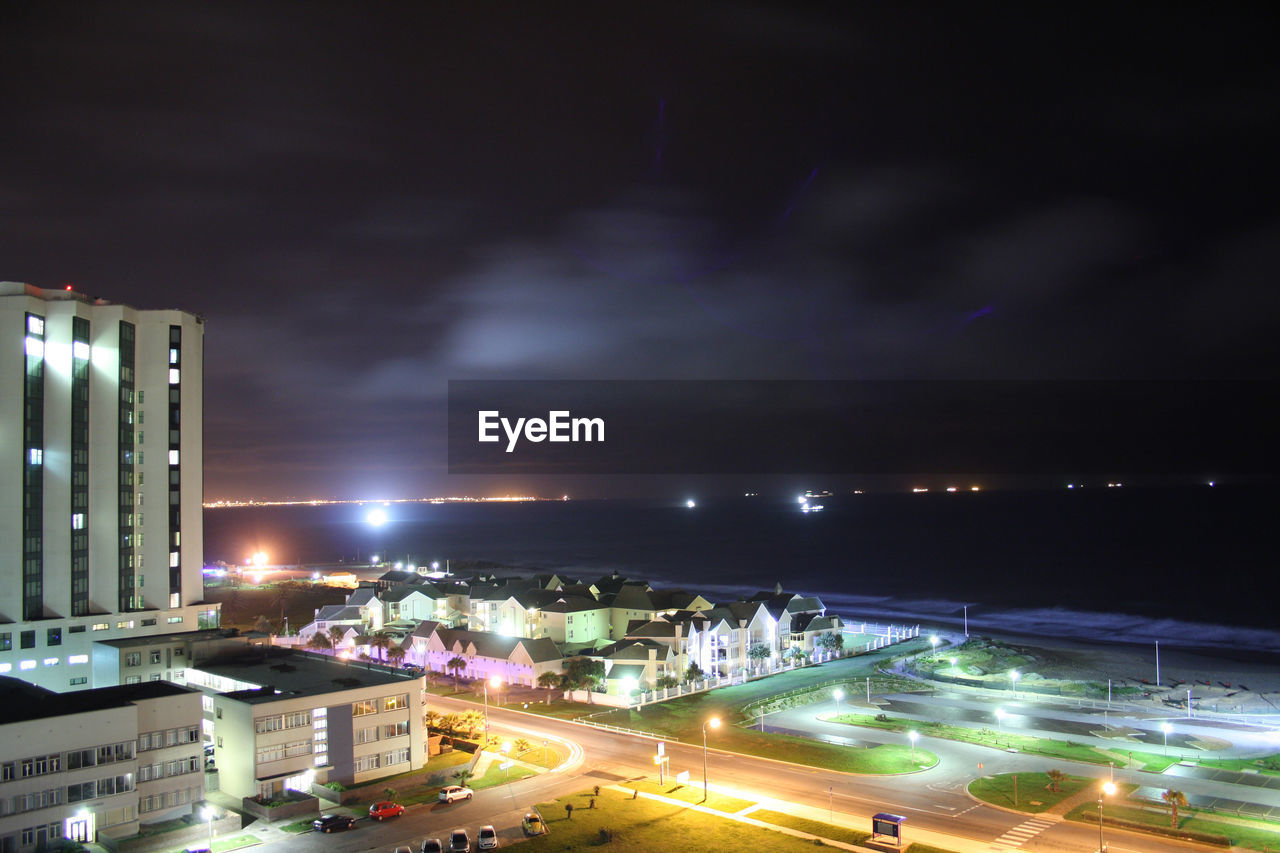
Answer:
[205, 485, 1280, 653]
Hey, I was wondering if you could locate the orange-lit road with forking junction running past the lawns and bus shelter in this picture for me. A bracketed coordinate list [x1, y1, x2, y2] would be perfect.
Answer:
[252, 697, 1228, 853]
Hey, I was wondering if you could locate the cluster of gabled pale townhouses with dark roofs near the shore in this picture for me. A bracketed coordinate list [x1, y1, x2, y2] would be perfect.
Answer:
[351, 576, 844, 690]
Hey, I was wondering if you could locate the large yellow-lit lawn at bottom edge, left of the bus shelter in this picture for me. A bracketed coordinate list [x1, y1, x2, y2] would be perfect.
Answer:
[521, 790, 885, 853]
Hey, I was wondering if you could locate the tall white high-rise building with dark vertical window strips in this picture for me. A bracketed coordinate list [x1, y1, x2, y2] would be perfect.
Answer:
[0, 282, 219, 690]
